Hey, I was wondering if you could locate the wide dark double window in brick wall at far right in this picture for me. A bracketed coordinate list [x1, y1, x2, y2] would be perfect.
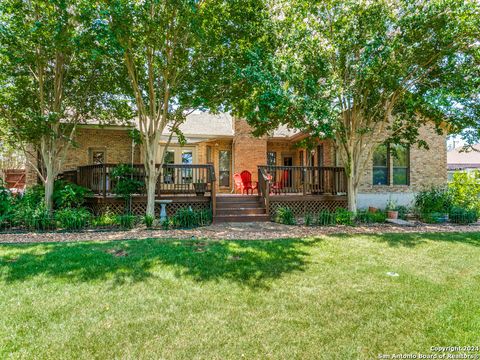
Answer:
[373, 144, 410, 185]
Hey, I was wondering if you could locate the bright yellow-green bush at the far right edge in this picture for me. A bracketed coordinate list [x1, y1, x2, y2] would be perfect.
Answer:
[448, 170, 480, 213]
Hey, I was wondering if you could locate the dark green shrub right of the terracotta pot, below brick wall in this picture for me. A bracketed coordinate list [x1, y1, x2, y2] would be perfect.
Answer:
[415, 187, 452, 221]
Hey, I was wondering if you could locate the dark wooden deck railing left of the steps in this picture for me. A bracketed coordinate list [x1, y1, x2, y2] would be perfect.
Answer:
[68, 164, 215, 197]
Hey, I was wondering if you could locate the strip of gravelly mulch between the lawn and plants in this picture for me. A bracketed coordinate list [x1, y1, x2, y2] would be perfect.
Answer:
[0, 222, 480, 245]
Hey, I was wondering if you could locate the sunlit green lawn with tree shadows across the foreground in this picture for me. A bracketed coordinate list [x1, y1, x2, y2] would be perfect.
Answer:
[0, 233, 480, 359]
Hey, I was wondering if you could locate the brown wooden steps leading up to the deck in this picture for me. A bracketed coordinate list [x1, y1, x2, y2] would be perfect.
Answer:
[214, 195, 270, 223]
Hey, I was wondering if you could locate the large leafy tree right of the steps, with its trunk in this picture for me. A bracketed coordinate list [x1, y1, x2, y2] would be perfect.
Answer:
[236, 0, 480, 214]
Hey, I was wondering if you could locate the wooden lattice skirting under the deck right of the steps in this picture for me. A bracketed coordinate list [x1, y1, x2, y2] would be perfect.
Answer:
[270, 200, 347, 219]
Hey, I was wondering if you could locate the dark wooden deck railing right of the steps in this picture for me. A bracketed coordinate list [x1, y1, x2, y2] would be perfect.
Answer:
[258, 166, 347, 198]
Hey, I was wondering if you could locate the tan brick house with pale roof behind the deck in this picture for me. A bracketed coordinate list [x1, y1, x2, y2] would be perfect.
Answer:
[27, 113, 447, 219]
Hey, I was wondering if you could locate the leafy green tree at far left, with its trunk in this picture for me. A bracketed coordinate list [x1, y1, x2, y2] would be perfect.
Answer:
[0, 0, 131, 210]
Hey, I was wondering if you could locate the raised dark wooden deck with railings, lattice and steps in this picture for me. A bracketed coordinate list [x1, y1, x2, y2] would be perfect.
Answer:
[61, 164, 347, 221]
